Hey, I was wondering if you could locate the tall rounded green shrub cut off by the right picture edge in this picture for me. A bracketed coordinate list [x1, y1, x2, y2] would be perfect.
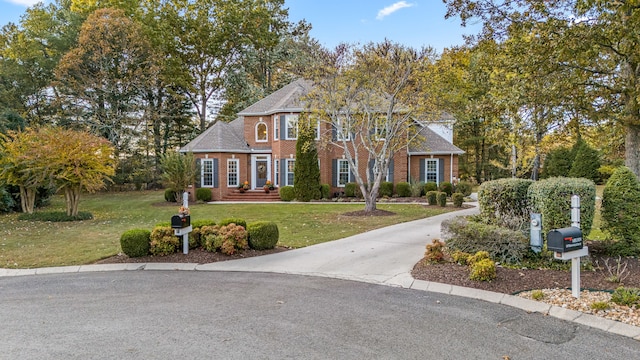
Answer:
[601, 166, 640, 256]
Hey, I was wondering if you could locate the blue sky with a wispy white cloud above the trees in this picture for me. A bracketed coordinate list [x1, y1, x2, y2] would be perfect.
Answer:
[0, 0, 479, 51]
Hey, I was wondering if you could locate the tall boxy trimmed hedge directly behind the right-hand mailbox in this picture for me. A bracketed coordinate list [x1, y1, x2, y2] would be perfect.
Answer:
[526, 177, 596, 237]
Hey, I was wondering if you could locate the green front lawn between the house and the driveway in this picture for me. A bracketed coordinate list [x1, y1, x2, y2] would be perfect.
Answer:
[0, 191, 453, 268]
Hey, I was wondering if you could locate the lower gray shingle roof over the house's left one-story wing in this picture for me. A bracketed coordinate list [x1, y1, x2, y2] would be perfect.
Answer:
[180, 117, 251, 153]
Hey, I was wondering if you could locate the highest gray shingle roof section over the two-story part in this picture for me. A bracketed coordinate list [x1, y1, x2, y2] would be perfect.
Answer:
[238, 79, 312, 116]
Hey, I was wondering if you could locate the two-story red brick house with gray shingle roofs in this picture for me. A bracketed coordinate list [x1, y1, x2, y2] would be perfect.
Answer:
[180, 79, 464, 200]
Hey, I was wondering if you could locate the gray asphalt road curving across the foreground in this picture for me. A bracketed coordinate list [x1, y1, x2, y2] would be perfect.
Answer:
[0, 271, 640, 360]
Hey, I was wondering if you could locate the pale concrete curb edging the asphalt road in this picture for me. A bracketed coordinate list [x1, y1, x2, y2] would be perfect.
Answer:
[0, 263, 640, 341]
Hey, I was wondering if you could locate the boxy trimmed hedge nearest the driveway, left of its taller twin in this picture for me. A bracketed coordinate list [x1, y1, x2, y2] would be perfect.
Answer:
[478, 179, 533, 230]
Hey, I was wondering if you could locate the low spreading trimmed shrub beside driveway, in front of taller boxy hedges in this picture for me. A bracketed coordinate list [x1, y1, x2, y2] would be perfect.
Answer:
[442, 217, 530, 264]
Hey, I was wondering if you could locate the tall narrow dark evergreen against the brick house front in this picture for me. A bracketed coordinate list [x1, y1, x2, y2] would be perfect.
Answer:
[293, 119, 322, 201]
